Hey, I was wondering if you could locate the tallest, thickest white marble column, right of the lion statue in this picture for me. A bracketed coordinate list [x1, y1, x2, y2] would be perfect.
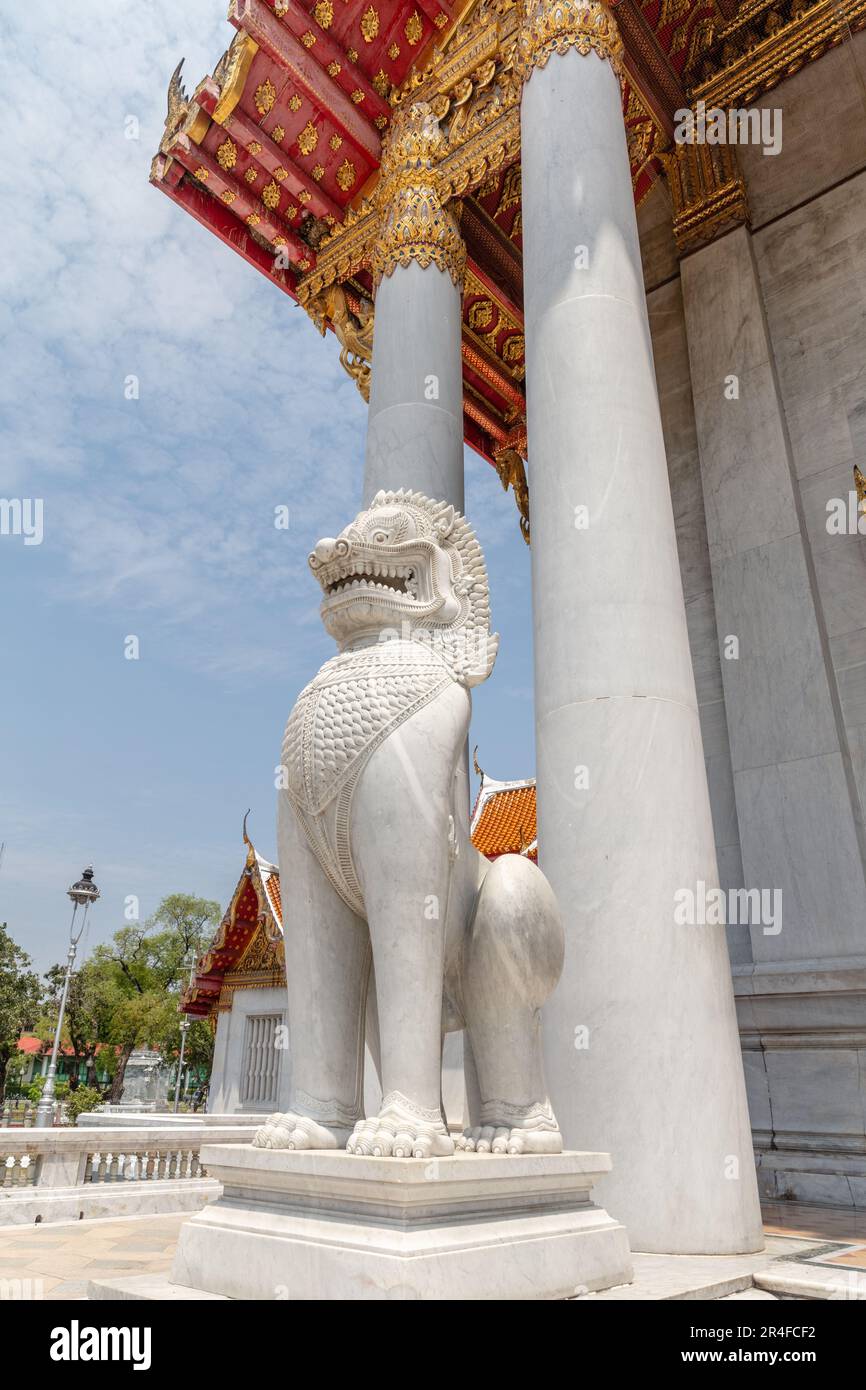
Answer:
[520, 0, 762, 1254]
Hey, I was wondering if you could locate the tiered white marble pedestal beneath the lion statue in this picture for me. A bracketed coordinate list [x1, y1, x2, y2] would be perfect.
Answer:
[171, 1144, 632, 1301]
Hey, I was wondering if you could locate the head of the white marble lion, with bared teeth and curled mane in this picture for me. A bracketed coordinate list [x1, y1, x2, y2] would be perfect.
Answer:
[309, 491, 499, 685]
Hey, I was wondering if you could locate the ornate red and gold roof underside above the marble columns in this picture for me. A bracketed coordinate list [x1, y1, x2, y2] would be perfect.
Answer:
[152, 0, 866, 537]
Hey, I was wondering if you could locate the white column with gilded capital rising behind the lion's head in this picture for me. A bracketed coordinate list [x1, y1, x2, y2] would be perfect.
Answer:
[364, 103, 466, 512]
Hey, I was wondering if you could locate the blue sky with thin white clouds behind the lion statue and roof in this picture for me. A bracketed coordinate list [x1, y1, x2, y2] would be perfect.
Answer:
[0, 0, 534, 970]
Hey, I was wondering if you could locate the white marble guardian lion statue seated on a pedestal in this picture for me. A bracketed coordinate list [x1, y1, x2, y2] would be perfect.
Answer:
[253, 492, 563, 1158]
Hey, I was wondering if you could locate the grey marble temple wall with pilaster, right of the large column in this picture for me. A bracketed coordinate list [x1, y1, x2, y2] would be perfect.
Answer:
[635, 35, 866, 1207]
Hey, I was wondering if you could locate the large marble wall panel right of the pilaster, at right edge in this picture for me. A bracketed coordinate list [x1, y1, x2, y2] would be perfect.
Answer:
[753, 169, 866, 861]
